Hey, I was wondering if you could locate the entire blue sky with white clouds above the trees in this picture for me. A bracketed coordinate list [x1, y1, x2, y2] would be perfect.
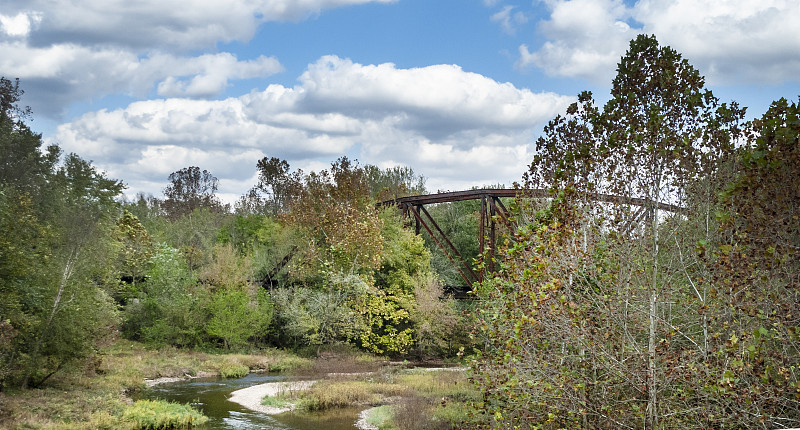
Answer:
[0, 0, 800, 202]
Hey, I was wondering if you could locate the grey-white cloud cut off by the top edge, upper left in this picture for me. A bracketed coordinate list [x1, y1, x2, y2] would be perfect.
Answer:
[3, 0, 397, 51]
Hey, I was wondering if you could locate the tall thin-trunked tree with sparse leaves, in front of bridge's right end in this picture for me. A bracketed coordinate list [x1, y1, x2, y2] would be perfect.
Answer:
[479, 36, 744, 428]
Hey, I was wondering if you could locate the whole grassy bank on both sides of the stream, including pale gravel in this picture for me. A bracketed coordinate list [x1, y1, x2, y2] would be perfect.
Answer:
[0, 340, 475, 429]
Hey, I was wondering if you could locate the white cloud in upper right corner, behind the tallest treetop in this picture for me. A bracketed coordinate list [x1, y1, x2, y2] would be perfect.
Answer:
[517, 0, 800, 84]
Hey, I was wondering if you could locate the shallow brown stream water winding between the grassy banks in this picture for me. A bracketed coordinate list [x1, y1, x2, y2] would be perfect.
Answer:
[142, 373, 360, 430]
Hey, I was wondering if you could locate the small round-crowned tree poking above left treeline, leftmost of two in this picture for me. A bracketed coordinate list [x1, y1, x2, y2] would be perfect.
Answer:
[163, 166, 225, 219]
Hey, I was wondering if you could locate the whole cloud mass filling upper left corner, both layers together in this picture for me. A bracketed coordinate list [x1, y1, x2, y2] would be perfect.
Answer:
[0, 0, 396, 118]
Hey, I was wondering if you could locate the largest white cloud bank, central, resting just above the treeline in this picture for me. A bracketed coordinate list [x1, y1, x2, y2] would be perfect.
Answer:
[57, 56, 572, 200]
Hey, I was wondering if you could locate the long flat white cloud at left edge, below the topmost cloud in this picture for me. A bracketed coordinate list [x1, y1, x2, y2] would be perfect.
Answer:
[0, 42, 283, 117]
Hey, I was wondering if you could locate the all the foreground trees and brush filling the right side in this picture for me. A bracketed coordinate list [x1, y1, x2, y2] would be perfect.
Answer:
[474, 36, 800, 428]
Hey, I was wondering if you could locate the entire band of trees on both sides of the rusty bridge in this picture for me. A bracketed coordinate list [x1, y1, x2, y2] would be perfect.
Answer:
[0, 32, 800, 429]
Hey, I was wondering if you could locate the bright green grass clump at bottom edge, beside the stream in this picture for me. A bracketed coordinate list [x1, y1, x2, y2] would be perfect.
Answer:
[122, 400, 208, 430]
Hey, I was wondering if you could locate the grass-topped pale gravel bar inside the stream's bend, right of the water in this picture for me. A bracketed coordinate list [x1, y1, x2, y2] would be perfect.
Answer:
[244, 366, 479, 430]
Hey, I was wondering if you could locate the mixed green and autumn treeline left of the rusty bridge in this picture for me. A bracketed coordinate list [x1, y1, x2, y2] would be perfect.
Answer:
[0, 79, 477, 388]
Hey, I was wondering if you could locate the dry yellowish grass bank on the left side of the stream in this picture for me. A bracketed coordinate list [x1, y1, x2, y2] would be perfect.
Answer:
[0, 340, 311, 429]
